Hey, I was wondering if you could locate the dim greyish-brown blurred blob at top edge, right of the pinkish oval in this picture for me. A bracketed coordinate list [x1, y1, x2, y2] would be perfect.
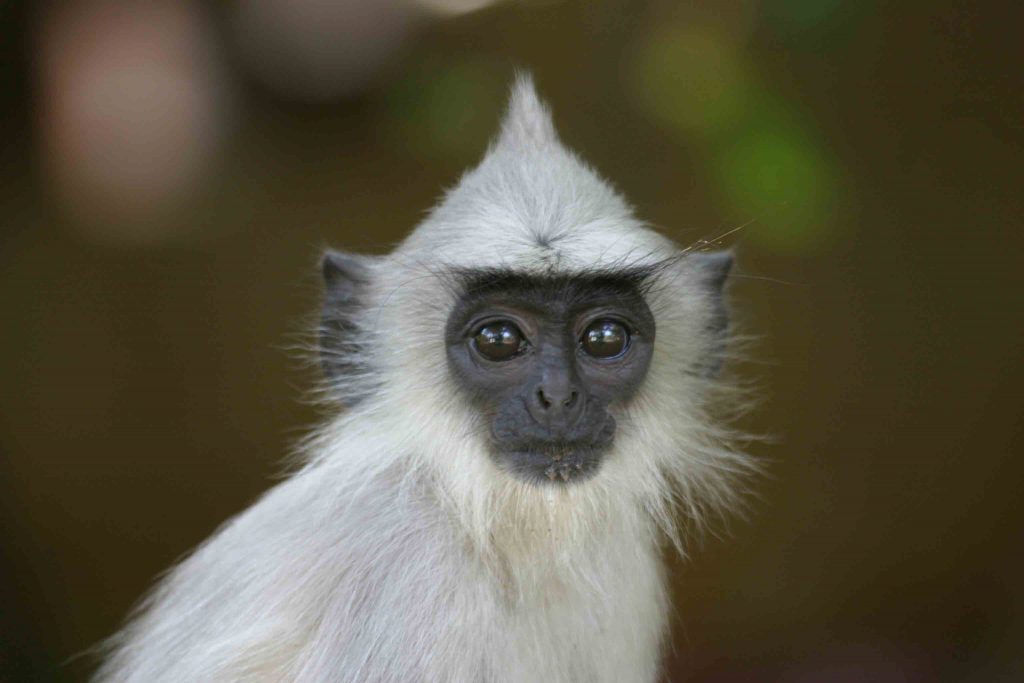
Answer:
[232, 0, 417, 100]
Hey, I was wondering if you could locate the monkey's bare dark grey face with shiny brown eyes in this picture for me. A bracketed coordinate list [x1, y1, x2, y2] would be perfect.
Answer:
[446, 272, 654, 484]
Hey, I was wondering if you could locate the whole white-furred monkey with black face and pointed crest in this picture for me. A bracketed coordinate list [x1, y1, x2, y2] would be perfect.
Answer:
[96, 77, 750, 683]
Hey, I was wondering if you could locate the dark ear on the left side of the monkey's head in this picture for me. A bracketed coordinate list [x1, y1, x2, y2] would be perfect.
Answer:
[319, 251, 376, 404]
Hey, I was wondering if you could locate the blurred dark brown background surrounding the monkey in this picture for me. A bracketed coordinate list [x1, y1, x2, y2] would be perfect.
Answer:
[0, 0, 1024, 683]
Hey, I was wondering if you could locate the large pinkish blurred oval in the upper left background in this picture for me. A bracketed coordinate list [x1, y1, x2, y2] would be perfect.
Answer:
[39, 0, 223, 243]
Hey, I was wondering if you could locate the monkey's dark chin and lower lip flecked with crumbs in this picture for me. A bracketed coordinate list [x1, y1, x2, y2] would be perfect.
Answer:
[495, 443, 610, 486]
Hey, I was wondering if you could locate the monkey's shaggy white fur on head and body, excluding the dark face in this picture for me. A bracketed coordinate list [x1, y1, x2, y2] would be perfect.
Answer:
[96, 77, 751, 683]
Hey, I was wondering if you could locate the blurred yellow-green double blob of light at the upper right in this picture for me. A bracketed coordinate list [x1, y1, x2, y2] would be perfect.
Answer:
[630, 25, 838, 251]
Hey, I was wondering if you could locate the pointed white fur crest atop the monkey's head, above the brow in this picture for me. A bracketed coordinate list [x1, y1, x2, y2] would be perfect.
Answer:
[394, 76, 677, 272]
